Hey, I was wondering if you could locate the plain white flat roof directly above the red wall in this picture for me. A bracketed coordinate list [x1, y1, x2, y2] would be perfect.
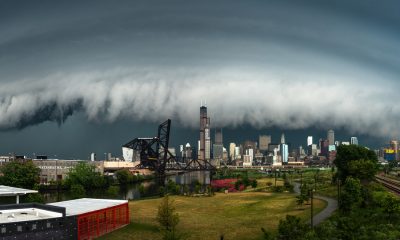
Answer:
[47, 198, 128, 216]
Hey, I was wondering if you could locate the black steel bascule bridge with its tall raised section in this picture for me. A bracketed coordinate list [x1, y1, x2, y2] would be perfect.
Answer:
[123, 119, 215, 176]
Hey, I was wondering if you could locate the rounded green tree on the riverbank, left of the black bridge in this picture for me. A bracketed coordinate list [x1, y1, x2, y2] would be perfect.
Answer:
[66, 162, 106, 190]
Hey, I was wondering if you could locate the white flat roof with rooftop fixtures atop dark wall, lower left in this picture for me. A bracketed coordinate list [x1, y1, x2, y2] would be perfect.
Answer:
[0, 208, 62, 223]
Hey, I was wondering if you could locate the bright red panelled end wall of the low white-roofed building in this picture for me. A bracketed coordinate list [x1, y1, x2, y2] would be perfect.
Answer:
[77, 203, 129, 240]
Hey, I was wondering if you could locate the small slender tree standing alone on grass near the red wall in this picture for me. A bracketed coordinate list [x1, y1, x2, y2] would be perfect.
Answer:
[157, 195, 180, 240]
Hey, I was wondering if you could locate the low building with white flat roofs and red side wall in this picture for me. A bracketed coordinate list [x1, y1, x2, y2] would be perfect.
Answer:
[0, 198, 129, 240]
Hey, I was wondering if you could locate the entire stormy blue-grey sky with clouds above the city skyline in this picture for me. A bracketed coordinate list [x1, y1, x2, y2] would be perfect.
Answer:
[0, 0, 400, 157]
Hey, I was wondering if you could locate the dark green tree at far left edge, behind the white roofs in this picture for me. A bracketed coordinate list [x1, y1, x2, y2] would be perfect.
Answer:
[0, 161, 40, 189]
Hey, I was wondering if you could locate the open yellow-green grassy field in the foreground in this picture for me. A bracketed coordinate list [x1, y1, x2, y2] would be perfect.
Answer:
[99, 192, 326, 240]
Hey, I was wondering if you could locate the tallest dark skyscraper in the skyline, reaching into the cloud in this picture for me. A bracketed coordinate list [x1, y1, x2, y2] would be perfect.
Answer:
[199, 105, 211, 160]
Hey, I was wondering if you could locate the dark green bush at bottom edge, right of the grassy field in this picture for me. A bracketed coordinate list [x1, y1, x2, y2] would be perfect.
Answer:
[278, 215, 310, 240]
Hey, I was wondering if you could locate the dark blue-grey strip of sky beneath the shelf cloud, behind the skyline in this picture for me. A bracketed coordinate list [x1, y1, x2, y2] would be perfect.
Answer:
[0, 113, 390, 160]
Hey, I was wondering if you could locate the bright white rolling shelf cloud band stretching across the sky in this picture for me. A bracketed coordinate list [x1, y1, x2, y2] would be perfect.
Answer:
[0, 66, 400, 136]
